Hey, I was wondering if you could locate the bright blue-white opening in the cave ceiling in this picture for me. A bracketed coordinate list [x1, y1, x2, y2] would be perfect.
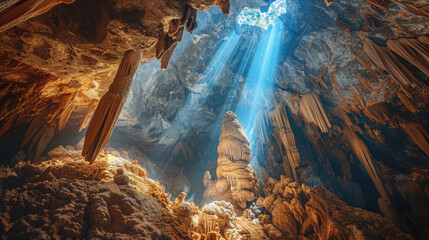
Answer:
[237, 0, 286, 30]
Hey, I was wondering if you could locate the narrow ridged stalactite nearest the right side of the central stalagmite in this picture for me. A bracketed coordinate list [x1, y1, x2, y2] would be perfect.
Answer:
[271, 104, 301, 182]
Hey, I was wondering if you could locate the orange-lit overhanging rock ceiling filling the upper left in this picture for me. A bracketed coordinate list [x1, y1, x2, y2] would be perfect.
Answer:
[0, 0, 229, 160]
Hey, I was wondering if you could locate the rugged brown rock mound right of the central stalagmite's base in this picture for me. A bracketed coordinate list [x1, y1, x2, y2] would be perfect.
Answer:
[259, 176, 413, 239]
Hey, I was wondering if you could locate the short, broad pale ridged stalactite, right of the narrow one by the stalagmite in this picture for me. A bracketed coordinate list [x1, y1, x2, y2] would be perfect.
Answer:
[299, 93, 331, 133]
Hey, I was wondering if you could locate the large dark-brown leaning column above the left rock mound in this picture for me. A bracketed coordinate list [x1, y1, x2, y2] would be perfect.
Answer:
[82, 50, 141, 162]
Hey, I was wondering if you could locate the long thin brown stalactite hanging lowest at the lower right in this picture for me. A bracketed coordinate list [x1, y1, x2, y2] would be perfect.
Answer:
[344, 127, 397, 223]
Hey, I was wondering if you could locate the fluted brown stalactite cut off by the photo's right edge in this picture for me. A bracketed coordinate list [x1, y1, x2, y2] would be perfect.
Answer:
[387, 36, 429, 76]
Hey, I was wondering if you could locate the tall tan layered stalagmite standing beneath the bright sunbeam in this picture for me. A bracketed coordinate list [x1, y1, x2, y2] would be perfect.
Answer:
[204, 112, 259, 209]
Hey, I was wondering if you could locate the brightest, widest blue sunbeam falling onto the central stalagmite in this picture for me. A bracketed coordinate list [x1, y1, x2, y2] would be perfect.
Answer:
[235, 21, 283, 163]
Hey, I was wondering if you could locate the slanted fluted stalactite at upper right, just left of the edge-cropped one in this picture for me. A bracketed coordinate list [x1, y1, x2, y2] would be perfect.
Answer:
[363, 38, 417, 86]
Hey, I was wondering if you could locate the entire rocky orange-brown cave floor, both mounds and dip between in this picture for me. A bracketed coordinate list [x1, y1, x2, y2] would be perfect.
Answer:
[0, 141, 420, 240]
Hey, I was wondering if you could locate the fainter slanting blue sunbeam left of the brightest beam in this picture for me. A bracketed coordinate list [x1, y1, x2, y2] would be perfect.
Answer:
[160, 31, 240, 143]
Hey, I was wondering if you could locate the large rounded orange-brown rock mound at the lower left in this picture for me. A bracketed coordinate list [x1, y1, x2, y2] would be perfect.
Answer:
[0, 143, 192, 240]
